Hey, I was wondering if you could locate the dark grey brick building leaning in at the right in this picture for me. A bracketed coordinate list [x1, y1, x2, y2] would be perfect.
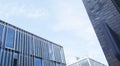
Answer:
[83, 0, 120, 66]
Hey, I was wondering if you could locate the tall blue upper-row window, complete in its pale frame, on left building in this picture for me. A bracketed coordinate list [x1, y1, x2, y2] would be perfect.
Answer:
[6, 28, 15, 48]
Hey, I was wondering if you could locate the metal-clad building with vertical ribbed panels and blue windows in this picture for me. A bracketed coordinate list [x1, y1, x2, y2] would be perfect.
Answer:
[0, 20, 66, 66]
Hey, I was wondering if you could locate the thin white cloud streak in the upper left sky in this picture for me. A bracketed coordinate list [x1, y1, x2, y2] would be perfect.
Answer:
[0, 3, 48, 19]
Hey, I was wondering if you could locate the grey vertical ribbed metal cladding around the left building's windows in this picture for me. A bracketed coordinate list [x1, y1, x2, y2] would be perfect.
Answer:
[0, 22, 66, 66]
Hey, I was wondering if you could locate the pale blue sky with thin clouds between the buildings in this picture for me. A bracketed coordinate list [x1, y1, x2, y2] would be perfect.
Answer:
[0, 0, 107, 65]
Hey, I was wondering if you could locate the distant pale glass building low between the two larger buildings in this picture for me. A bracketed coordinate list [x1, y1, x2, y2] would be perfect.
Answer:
[68, 58, 106, 66]
